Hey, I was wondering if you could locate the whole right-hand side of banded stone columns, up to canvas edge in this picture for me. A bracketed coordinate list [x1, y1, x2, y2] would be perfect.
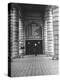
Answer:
[44, 6, 59, 56]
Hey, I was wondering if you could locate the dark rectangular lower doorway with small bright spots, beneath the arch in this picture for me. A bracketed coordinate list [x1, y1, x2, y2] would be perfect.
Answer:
[26, 40, 43, 55]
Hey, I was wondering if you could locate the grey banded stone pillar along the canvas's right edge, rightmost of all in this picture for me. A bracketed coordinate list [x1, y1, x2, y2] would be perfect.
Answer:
[52, 6, 59, 59]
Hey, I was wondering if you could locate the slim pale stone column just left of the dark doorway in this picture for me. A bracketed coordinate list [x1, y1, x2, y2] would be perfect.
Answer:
[19, 16, 24, 56]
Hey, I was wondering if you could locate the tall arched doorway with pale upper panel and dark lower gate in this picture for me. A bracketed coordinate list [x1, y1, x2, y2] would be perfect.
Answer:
[26, 22, 43, 55]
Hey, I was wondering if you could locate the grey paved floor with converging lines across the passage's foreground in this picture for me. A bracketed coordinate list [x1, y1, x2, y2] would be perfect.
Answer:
[11, 55, 58, 77]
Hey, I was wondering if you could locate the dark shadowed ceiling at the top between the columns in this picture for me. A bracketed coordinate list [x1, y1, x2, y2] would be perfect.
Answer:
[20, 4, 47, 18]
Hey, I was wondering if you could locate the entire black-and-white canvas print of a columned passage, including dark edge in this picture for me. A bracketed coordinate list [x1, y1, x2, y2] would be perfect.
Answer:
[8, 3, 59, 77]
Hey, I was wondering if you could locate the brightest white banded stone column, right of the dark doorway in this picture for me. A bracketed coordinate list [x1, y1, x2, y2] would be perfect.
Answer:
[47, 8, 54, 56]
